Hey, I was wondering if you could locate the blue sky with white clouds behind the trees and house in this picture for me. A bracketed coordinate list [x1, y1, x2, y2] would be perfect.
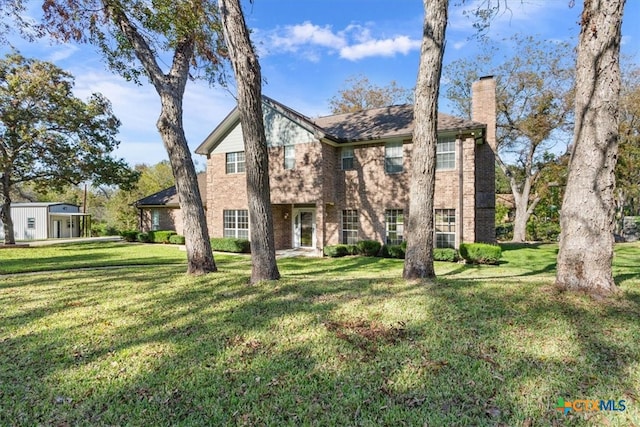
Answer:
[0, 0, 640, 168]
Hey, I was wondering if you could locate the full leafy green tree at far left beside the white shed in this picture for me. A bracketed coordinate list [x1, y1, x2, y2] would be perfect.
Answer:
[0, 53, 137, 244]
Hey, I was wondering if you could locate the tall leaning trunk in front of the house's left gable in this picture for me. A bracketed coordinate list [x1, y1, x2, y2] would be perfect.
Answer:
[219, 0, 280, 283]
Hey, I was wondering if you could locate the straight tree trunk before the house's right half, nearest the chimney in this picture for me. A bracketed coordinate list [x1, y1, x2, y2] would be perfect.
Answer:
[402, 0, 449, 280]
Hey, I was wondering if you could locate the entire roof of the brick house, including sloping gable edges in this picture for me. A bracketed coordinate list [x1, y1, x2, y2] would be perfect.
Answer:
[196, 96, 486, 155]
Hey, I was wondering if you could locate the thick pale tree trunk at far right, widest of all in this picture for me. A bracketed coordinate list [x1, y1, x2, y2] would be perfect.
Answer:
[556, 0, 624, 294]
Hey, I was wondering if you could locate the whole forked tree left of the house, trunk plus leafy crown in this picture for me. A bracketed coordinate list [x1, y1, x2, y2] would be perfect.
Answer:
[37, 0, 222, 274]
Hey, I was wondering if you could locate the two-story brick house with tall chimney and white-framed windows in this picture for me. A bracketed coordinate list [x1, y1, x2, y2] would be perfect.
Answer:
[196, 78, 495, 249]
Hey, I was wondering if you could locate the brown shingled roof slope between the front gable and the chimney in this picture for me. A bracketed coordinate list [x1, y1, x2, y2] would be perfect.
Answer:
[313, 104, 485, 142]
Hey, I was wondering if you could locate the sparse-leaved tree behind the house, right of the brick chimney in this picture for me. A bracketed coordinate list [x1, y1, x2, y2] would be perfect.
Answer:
[445, 35, 575, 242]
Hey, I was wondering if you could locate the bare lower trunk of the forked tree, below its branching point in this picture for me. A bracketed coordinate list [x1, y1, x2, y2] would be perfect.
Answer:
[157, 91, 217, 275]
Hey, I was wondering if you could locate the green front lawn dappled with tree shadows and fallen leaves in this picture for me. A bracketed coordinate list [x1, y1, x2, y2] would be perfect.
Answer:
[0, 243, 640, 426]
